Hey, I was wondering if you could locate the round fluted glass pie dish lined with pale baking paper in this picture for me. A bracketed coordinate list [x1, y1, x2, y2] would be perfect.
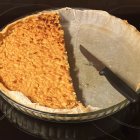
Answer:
[0, 8, 140, 120]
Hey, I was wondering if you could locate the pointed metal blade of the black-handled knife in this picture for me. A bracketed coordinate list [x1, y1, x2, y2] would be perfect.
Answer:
[80, 45, 106, 71]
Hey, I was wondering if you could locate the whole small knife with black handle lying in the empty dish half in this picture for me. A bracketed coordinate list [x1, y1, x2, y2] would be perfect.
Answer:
[80, 45, 139, 103]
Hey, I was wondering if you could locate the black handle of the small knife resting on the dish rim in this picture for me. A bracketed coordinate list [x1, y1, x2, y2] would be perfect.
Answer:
[99, 67, 139, 103]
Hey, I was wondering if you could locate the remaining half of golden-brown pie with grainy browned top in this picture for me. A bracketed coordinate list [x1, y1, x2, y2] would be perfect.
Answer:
[0, 12, 87, 112]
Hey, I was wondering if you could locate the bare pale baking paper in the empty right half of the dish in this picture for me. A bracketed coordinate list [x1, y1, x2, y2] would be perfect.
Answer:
[61, 8, 140, 108]
